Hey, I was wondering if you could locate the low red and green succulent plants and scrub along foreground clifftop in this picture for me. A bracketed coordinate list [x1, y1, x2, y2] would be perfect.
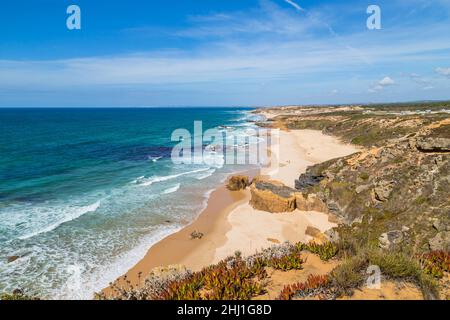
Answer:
[97, 242, 449, 300]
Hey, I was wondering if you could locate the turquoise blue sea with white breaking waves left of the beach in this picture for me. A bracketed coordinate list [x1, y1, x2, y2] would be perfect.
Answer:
[0, 108, 260, 299]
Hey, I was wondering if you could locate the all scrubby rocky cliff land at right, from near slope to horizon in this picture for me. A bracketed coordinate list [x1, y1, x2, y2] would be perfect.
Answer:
[255, 106, 450, 252]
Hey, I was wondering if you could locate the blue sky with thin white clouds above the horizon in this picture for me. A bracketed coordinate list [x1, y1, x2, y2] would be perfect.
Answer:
[0, 0, 450, 107]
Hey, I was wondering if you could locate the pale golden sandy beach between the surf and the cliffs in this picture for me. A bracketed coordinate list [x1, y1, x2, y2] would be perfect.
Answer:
[105, 126, 358, 294]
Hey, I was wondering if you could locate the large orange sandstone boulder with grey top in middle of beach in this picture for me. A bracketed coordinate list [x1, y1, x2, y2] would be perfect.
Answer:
[250, 178, 296, 212]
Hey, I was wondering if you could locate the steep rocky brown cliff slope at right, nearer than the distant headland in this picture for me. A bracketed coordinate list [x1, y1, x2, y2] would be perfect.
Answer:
[296, 121, 450, 251]
